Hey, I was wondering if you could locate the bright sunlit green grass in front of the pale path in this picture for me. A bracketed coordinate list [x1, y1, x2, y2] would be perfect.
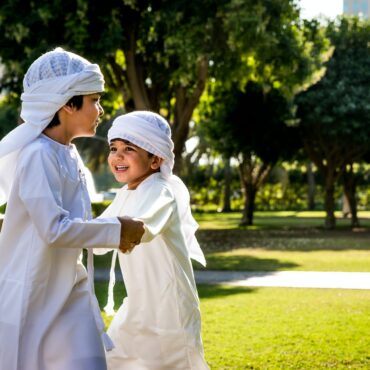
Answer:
[96, 283, 370, 370]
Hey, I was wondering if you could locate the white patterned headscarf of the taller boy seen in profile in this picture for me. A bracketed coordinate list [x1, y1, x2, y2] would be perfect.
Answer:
[0, 48, 104, 205]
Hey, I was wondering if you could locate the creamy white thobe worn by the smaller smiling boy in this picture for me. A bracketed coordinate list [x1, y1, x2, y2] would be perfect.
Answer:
[97, 173, 208, 370]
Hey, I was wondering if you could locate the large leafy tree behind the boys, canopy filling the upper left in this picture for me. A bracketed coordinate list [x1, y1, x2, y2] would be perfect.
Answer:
[0, 0, 306, 172]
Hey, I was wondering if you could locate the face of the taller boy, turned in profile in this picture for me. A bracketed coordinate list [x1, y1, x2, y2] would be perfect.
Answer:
[69, 93, 104, 138]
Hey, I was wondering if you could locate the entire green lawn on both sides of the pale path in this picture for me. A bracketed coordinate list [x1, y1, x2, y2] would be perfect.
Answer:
[95, 212, 370, 370]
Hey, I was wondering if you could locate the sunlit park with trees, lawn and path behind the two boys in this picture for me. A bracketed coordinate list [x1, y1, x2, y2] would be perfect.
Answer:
[0, 0, 370, 370]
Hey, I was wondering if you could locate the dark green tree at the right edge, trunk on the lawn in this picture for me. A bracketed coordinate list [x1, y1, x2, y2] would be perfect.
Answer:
[296, 18, 370, 229]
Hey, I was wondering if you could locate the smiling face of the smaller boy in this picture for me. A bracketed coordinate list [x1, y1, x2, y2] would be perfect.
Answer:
[108, 139, 162, 190]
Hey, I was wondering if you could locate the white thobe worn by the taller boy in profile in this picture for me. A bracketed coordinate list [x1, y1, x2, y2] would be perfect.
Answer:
[0, 135, 120, 370]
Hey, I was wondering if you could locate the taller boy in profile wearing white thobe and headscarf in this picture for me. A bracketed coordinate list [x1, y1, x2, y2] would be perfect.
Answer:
[0, 48, 144, 370]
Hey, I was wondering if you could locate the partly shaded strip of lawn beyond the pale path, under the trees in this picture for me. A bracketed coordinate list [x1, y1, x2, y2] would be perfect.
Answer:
[95, 212, 370, 272]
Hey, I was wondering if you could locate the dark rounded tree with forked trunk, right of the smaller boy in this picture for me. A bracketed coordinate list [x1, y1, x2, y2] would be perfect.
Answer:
[199, 82, 300, 225]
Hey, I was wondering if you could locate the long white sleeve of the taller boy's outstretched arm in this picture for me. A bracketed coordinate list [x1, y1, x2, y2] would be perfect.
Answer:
[18, 148, 121, 248]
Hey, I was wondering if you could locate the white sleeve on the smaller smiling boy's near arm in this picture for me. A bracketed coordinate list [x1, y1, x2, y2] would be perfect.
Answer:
[132, 183, 176, 243]
